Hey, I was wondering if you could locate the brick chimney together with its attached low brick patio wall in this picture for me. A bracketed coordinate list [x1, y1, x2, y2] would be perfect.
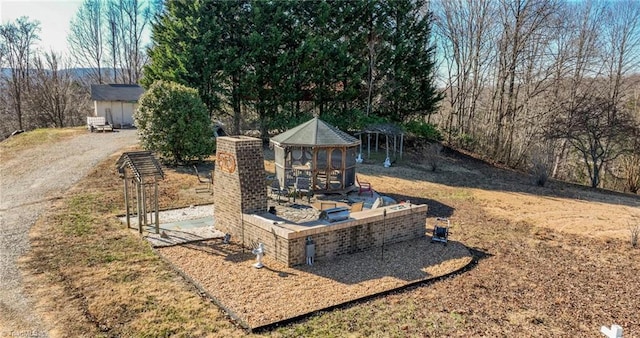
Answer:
[214, 136, 427, 266]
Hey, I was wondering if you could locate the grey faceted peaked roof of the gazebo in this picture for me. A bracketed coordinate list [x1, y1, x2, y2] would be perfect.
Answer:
[271, 117, 360, 147]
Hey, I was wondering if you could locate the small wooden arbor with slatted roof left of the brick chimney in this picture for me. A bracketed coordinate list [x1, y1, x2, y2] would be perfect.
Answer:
[116, 151, 164, 234]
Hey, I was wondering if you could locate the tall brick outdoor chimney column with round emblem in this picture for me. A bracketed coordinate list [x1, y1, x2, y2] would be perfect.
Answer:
[213, 136, 267, 244]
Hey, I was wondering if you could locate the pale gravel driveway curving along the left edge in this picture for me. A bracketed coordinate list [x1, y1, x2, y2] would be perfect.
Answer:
[0, 129, 138, 337]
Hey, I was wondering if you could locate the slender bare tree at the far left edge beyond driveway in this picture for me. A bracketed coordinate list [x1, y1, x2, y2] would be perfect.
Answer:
[0, 17, 40, 129]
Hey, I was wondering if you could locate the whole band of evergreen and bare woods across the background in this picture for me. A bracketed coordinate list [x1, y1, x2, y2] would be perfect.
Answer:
[0, 0, 640, 192]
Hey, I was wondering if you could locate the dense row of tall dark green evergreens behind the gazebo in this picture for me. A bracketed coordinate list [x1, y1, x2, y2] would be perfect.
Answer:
[141, 0, 440, 138]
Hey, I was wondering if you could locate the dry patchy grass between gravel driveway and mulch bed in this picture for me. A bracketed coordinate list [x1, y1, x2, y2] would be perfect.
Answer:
[23, 151, 239, 337]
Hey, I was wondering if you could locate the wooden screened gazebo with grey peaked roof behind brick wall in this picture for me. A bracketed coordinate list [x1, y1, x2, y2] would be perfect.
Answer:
[271, 117, 360, 193]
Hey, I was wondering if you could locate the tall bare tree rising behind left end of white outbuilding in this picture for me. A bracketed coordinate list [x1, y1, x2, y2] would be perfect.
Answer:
[67, 0, 105, 83]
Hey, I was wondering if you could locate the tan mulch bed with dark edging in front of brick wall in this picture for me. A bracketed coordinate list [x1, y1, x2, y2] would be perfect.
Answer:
[158, 237, 472, 329]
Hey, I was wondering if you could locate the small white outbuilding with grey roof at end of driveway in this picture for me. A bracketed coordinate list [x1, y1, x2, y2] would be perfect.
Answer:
[91, 84, 144, 128]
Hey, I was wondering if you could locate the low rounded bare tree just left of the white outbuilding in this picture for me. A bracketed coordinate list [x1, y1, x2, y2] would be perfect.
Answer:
[29, 52, 89, 127]
